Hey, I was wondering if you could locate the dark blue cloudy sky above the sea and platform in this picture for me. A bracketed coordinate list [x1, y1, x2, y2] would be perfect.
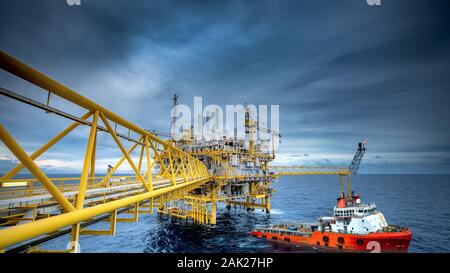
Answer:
[0, 0, 450, 173]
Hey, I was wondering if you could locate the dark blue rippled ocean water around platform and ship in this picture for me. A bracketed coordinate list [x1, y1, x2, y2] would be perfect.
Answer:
[37, 175, 450, 252]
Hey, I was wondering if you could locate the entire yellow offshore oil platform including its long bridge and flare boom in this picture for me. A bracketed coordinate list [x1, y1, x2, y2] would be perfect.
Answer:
[0, 52, 366, 253]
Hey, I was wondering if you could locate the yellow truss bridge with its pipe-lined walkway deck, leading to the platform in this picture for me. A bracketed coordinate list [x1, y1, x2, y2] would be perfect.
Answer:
[0, 52, 210, 252]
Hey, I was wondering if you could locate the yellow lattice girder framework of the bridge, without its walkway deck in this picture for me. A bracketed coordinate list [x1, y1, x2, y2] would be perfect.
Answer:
[0, 51, 211, 249]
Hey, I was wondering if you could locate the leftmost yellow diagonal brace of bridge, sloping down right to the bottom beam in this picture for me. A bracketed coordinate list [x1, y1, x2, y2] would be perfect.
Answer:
[0, 125, 75, 211]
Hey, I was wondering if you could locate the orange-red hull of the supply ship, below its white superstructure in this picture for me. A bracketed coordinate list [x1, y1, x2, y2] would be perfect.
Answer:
[250, 229, 412, 252]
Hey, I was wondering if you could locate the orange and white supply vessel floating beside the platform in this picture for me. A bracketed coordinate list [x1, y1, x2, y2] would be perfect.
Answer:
[250, 192, 412, 252]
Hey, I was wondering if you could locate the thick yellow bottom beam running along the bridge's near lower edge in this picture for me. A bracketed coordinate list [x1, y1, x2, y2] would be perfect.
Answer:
[0, 178, 209, 249]
